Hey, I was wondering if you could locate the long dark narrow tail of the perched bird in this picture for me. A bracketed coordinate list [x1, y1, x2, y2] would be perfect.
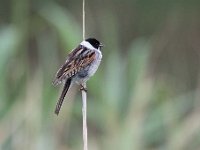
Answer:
[55, 78, 71, 115]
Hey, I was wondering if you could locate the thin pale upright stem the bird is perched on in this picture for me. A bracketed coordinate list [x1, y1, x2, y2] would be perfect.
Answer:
[82, 0, 88, 150]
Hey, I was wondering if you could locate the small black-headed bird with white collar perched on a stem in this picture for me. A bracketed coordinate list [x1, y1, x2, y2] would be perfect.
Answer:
[52, 38, 103, 115]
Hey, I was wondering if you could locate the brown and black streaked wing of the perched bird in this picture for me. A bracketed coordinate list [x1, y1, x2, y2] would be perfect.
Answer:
[53, 45, 96, 85]
